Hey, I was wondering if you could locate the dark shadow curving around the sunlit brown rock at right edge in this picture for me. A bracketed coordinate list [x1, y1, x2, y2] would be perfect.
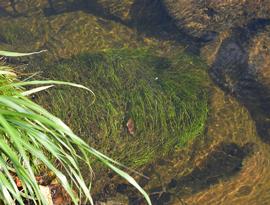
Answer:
[210, 19, 270, 143]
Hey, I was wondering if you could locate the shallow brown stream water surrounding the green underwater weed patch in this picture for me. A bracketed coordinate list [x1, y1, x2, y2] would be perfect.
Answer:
[0, 0, 270, 205]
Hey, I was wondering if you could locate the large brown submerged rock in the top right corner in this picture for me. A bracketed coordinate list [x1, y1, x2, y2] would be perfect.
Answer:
[163, 0, 270, 41]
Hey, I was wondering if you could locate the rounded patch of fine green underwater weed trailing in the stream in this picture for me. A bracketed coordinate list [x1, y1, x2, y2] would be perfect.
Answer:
[32, 49, 208, 167]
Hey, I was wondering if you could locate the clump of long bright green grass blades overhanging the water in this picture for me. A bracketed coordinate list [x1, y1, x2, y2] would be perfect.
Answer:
[0, 51, 151, 204]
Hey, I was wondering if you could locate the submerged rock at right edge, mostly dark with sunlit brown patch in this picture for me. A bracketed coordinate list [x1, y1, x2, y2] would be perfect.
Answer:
[210, 21, 270, 143]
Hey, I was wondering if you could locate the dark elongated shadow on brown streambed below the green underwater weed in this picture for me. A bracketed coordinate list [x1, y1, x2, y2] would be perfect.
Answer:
[111, 143, 254, 205]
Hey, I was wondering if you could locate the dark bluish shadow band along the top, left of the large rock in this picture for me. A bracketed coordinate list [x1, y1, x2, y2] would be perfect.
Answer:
[41, 0, 212, 54]
